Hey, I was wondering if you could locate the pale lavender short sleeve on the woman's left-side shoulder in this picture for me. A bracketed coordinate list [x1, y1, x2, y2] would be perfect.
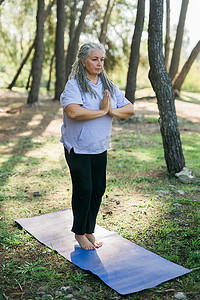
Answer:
[60, 78, 83, 109]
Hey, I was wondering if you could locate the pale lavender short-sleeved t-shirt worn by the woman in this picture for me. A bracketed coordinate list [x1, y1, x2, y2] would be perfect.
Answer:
[60, 77, 130, 154]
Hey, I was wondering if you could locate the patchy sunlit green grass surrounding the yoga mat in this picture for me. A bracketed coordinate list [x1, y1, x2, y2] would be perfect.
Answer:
[0, 93, 200, 299]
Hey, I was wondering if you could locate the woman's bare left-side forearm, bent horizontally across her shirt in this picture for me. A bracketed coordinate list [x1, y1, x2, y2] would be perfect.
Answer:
[65, 105, 107, 120]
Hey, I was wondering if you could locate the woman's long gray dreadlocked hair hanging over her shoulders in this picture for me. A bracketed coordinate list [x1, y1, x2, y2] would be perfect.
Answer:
[69, 43, 114, 98]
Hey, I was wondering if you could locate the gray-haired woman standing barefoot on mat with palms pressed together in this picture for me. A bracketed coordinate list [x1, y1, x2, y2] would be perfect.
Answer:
[60, 43, 134, 250]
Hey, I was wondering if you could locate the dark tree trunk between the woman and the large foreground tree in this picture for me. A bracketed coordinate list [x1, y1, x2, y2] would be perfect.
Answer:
[125, 0, 145, 103]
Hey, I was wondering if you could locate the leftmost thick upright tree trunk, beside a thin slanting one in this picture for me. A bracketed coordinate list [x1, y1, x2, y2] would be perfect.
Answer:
[27, 0, 44, 103]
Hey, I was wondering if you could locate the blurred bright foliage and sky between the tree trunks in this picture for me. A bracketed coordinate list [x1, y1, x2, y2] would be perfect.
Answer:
[0, 0, 200, 92]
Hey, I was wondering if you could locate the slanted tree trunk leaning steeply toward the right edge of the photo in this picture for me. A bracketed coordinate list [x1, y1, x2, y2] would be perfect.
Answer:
[173, 40, 200, 96]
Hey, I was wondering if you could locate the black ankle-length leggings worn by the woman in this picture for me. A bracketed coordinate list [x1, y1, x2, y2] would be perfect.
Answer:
[65, 149, 107, 235]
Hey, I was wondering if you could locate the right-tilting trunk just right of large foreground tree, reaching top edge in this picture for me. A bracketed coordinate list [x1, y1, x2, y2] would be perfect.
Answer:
[169, 0, 189, 80]
